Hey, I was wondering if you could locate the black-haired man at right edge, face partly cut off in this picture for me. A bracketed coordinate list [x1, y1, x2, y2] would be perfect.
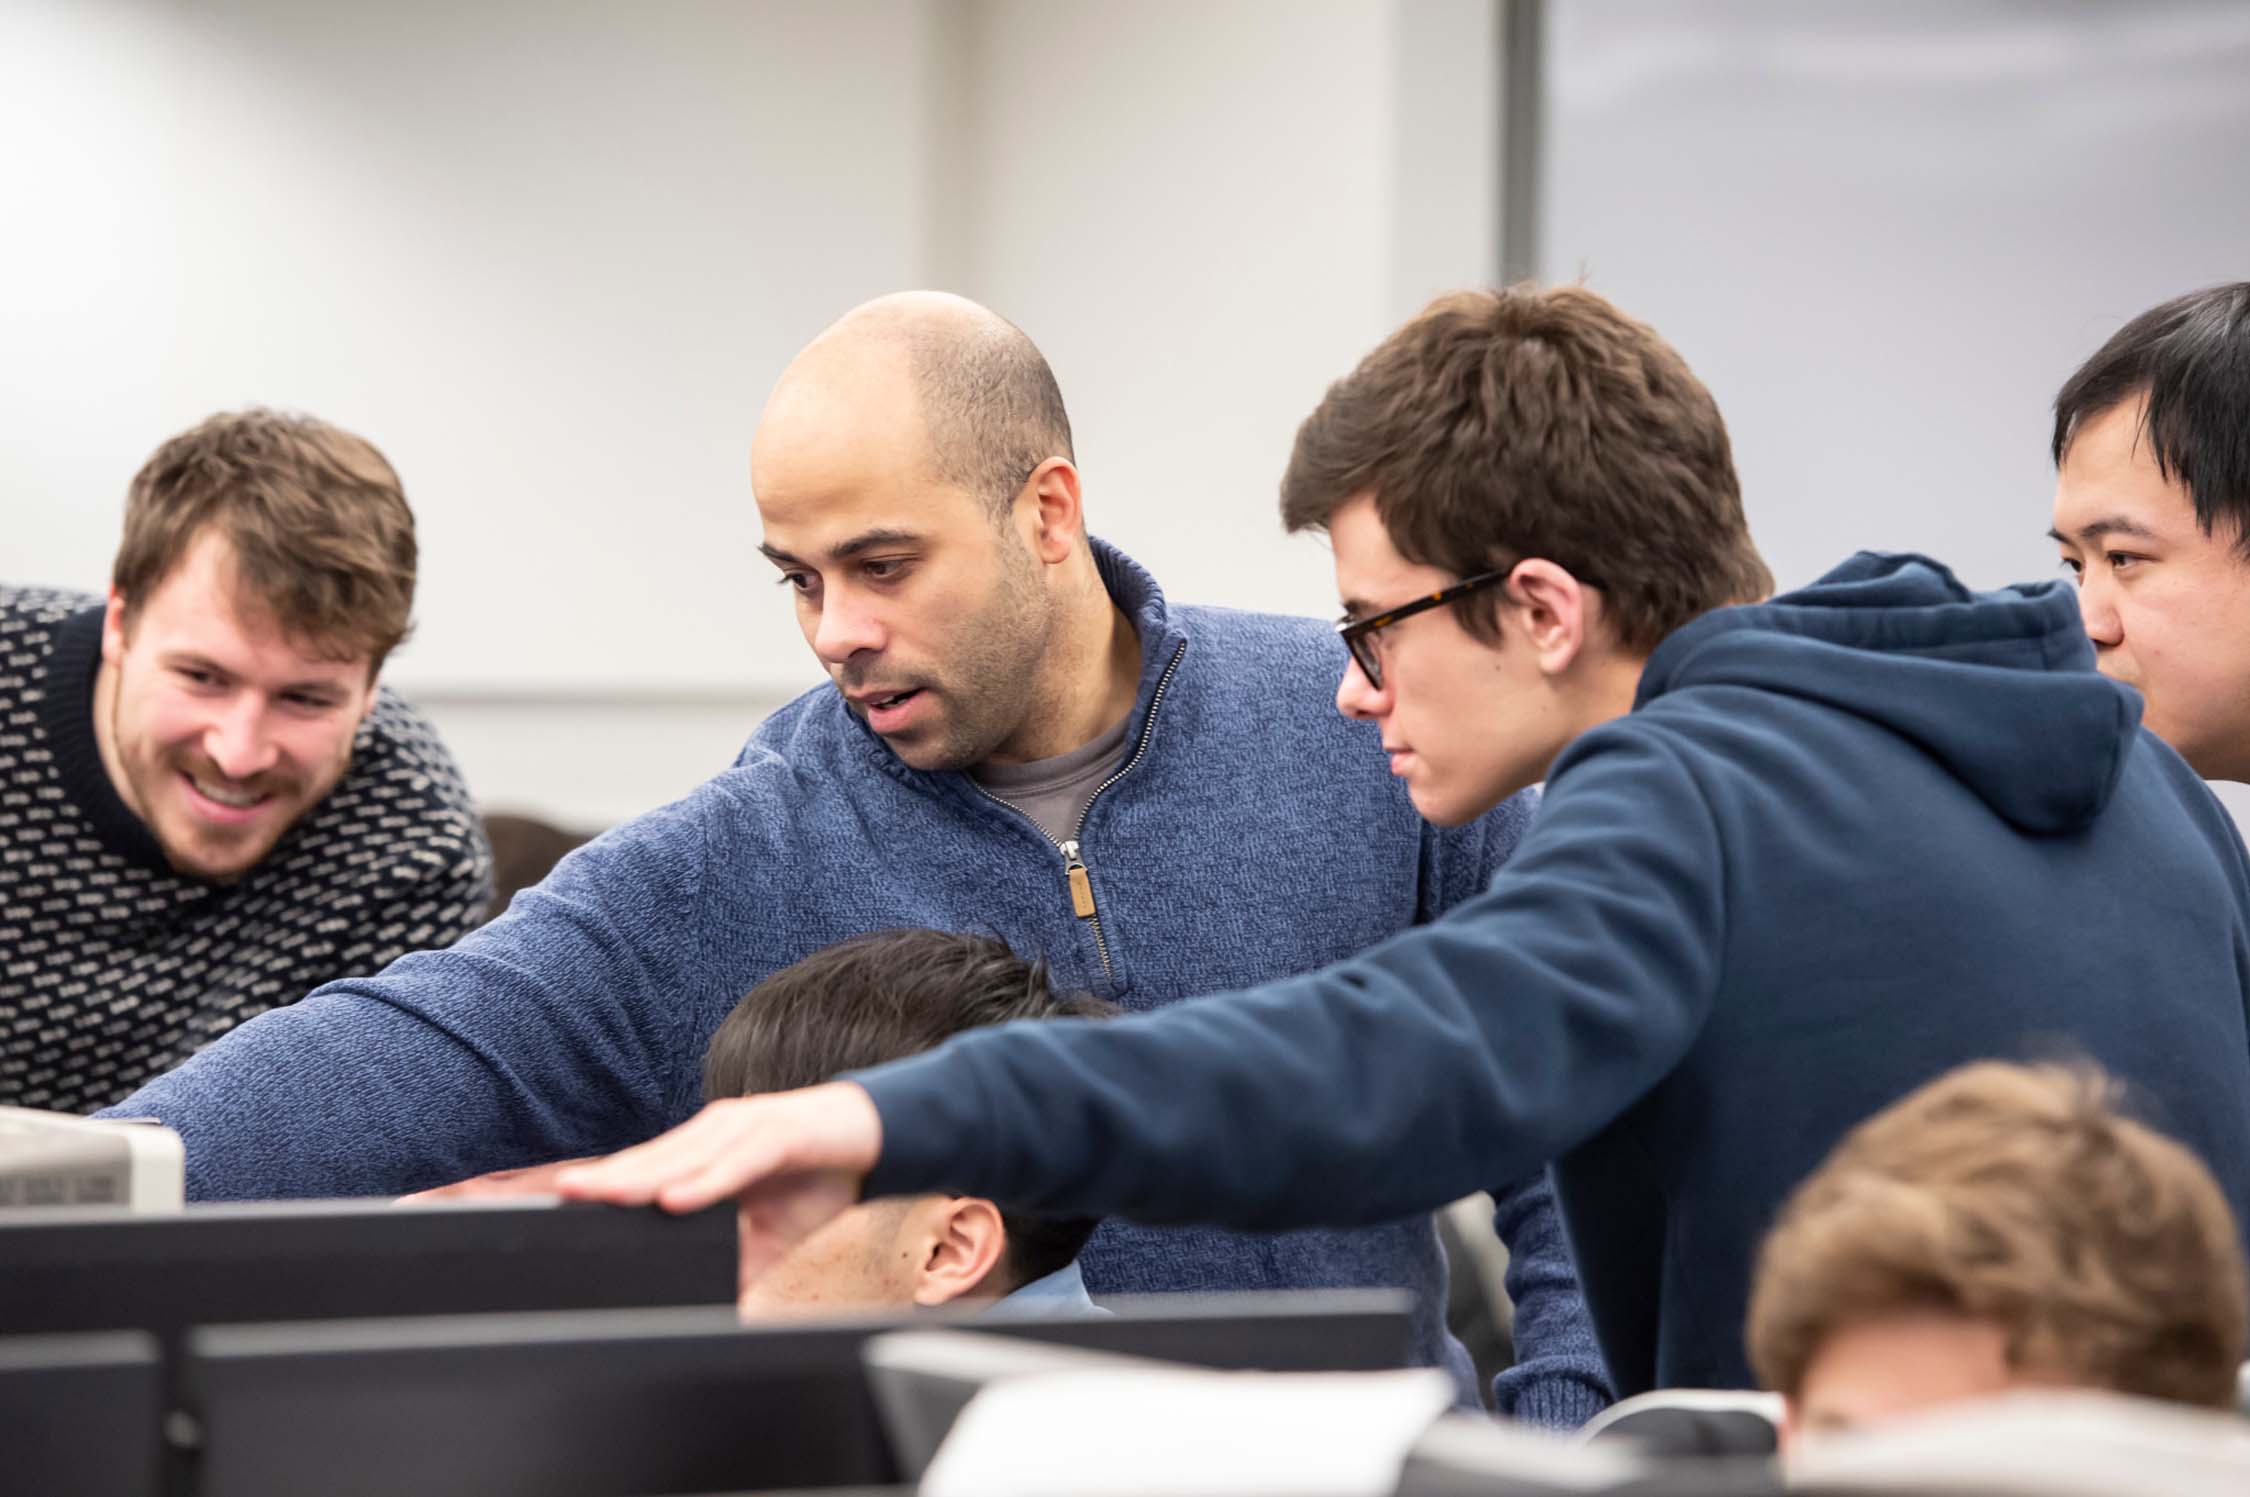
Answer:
[2048, 281, 2250, 781]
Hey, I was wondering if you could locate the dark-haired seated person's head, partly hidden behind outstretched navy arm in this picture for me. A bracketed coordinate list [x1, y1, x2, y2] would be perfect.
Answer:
[704, 930, 1116, 1312]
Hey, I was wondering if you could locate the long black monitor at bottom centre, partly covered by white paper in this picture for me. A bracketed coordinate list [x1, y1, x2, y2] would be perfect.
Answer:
[185, 1290, 1411, 1497]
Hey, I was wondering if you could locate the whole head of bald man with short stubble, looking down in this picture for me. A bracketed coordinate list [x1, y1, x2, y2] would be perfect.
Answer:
[749, 293, 1102, 770]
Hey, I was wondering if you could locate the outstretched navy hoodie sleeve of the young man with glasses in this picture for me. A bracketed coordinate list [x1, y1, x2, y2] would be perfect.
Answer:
[855, 718, 1724, 1231]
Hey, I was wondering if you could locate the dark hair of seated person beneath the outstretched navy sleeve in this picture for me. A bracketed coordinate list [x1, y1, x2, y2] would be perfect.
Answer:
[704, 930, 1116, 1288]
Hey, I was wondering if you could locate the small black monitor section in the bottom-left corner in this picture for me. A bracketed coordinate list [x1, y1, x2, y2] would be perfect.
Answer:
[0, 1330, 164, 1497]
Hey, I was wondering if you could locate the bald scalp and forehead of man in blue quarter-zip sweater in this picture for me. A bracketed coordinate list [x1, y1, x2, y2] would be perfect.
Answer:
[752, 290, 1073, 516]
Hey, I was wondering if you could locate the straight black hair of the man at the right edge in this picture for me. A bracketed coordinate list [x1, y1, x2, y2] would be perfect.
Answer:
[2054, 281, 2250, 558]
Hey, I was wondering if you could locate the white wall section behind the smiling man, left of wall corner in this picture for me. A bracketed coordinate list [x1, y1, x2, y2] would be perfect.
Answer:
[0, 0, 927, 689]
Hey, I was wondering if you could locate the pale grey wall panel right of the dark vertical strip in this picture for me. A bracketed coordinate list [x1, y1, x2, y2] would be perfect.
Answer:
[1544, 0, 2250, 815]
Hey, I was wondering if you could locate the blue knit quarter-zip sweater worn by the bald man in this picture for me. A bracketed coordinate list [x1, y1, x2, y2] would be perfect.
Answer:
[115, 543, 1607, 1425]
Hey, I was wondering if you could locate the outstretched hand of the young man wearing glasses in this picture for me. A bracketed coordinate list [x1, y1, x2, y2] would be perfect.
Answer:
[556, 1081, 882, 1285]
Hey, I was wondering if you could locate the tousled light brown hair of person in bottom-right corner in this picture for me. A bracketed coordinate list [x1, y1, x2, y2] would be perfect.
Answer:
[1748, 1063, 2250, 1407]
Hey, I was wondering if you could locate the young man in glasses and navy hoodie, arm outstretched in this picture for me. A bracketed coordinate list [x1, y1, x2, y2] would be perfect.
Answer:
[563, 288, 2250, 1393]
